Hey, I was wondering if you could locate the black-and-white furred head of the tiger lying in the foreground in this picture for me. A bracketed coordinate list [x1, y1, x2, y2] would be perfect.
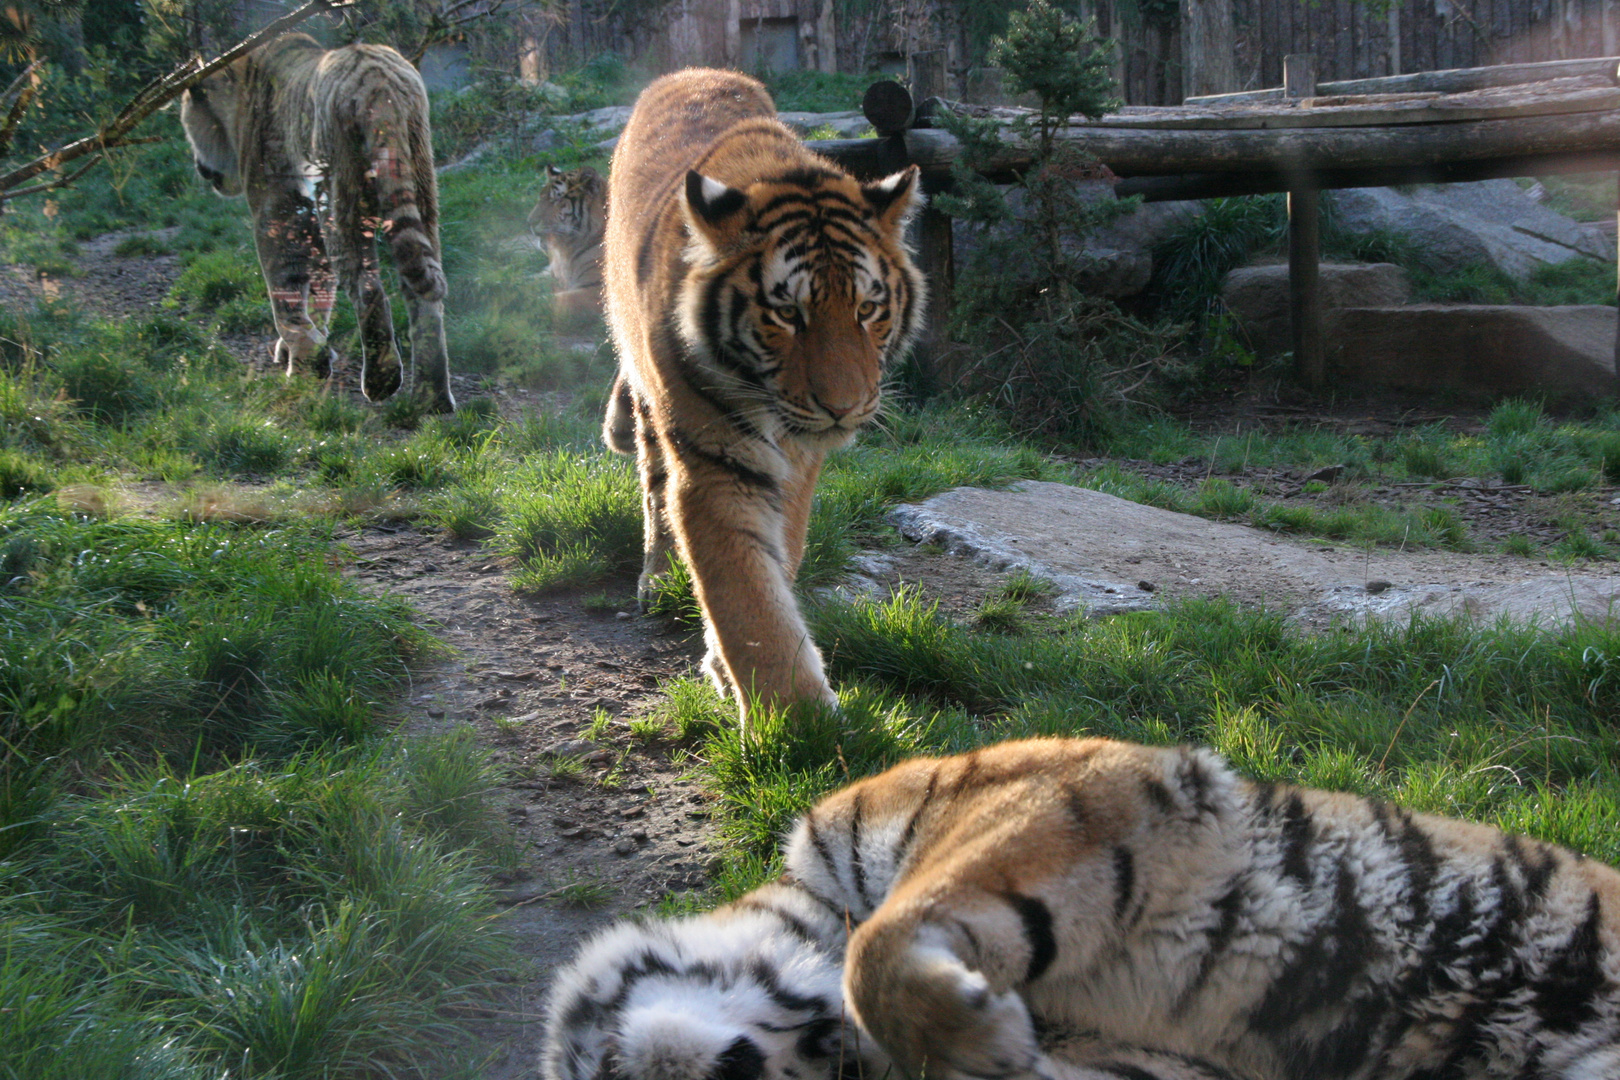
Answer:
[539, 887, 888, 1080]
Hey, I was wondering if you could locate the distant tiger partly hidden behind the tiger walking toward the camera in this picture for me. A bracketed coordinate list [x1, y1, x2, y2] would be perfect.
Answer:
[528, 165, 608, 324]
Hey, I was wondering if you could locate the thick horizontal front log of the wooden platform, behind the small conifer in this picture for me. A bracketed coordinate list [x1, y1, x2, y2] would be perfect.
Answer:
[900, 112, 1620, 181]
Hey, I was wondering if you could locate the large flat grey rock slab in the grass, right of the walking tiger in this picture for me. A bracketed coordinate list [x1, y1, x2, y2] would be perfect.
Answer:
[889, 481, 1620, 625]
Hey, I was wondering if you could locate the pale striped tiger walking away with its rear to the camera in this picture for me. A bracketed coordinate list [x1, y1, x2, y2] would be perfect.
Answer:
[180, 34, 455, 413]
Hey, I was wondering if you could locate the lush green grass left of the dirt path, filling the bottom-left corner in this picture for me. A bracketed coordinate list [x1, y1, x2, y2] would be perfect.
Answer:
[0, 502, 515, 1080]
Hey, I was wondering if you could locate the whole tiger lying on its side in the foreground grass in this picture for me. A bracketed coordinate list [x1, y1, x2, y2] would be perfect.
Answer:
[541, 738, 1620, 1080]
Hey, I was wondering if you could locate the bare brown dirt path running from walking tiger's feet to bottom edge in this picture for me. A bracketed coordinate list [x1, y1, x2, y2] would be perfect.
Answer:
[340, 528, 714, 1080]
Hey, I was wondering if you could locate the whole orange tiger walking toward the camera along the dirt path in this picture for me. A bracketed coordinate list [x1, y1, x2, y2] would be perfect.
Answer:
[604, 70, 923, 722]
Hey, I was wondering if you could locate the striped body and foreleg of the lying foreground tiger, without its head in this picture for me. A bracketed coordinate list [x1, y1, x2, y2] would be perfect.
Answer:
[806, 740, 1620, 1080]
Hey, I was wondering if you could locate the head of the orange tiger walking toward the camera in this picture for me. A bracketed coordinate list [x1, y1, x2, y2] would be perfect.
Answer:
[680, 164, 925, 445]
